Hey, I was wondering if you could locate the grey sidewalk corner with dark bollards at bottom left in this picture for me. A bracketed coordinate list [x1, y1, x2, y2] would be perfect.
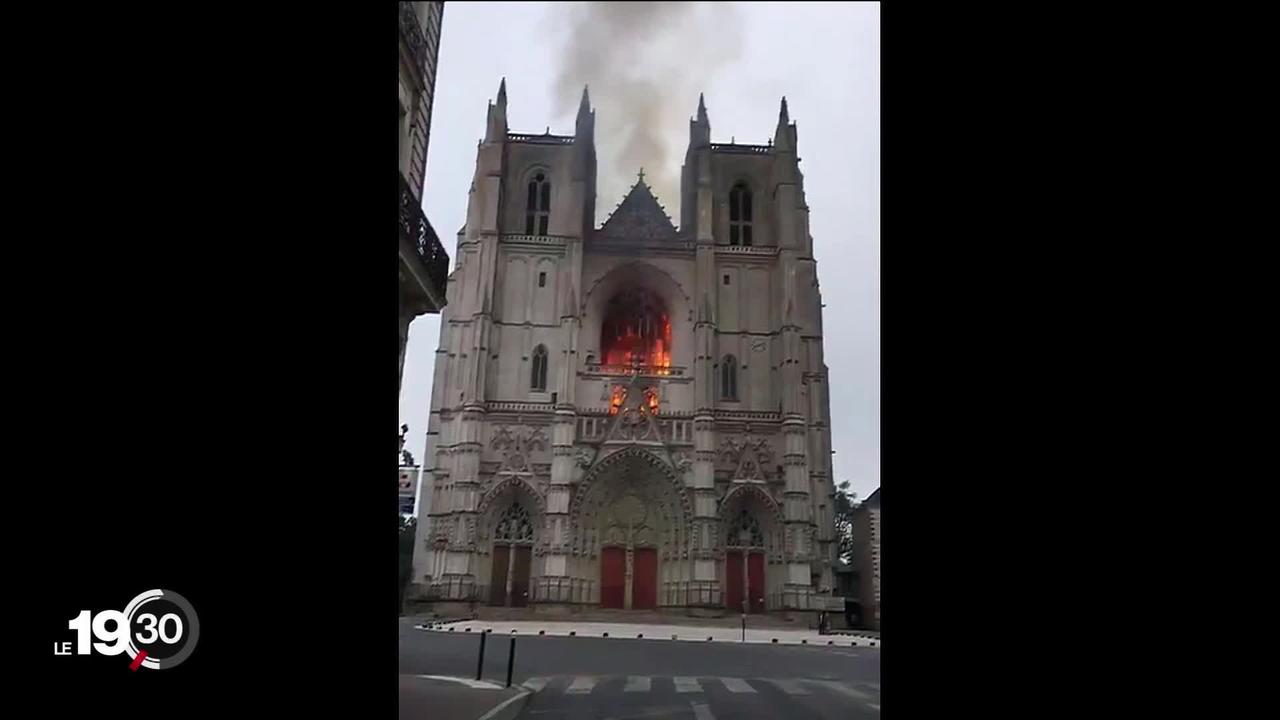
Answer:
[399, 675, 529, 720]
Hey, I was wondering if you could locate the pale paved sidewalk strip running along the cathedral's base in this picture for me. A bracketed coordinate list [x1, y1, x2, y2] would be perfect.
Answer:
[415, 618, 879, 647]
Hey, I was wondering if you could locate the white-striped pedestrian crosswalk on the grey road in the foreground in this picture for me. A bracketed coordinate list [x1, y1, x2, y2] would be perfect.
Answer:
[521, 675, 879, 710]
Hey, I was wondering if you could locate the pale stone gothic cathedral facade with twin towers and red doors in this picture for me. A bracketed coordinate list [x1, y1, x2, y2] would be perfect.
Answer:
[410, 83, 836, 612]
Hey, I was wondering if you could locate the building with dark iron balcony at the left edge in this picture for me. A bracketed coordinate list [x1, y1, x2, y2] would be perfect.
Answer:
[398, 3, 449, 392]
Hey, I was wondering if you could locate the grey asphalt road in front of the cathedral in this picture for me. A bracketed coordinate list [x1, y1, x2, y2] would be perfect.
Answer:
[399, 625, 879, 720]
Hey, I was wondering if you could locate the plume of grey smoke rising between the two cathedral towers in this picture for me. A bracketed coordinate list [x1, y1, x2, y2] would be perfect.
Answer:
[550, 3, 742, 223]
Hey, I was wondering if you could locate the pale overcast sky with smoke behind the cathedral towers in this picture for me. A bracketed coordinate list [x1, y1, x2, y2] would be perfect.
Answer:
[399, 3, 881, 497]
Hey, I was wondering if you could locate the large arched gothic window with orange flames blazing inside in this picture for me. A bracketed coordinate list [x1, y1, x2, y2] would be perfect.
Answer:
[600, 288, 671, 368]
